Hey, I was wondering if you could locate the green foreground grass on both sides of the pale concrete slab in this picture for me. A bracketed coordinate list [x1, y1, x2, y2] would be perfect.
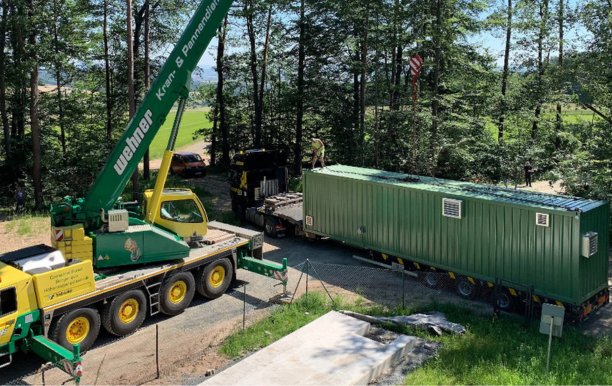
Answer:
[220, 293, 612, 385]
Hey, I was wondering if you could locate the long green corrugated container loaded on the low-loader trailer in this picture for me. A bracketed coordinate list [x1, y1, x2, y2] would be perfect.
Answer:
[304, 165, 610, 305]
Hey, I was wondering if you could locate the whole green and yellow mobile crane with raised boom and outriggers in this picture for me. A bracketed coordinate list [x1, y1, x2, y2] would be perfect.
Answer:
[0, 0, 287, 381]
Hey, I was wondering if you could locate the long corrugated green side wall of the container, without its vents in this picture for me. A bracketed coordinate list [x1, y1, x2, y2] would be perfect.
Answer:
[304, 172, 607, 303]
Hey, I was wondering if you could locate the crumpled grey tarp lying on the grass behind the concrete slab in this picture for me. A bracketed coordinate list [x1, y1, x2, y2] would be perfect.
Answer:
[340, 311, 465, 335]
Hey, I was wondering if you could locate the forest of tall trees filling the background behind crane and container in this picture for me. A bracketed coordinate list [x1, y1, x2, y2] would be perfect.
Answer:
[0, 0, 612, 210]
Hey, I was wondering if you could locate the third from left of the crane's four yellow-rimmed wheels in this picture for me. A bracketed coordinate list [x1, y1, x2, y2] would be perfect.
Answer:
[159, 272, 195, 315]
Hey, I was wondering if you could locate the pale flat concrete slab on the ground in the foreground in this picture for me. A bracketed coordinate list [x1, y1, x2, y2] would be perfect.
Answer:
[200, 311, 415, 386]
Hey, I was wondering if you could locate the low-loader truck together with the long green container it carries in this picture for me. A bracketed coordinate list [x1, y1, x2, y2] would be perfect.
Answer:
[230, 151, 610, 322]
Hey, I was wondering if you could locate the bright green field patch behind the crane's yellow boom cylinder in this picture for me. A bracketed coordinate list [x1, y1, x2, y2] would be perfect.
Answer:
[149, 107, 212, 159]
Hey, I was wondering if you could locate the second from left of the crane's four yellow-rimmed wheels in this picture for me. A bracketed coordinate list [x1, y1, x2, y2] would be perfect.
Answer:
[102, 290, 147, 336]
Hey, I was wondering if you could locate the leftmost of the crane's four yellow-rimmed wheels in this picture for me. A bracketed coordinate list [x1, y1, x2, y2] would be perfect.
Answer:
[49, 308, 100, 352]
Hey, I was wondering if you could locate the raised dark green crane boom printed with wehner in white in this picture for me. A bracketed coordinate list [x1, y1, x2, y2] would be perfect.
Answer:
[81, 0, 233, 215]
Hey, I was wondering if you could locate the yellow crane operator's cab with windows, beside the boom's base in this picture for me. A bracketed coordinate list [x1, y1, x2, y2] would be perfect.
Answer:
[144, 189, 208, 241]
